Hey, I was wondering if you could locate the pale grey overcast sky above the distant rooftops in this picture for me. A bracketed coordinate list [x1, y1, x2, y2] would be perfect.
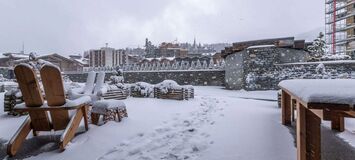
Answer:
[0, 0, 324, 55]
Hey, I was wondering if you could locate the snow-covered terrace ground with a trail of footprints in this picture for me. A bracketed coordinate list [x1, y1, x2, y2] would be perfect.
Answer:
[0, 87, 355, 160]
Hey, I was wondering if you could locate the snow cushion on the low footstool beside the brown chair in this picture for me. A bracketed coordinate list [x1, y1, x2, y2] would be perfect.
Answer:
[91, 99, 126, 114]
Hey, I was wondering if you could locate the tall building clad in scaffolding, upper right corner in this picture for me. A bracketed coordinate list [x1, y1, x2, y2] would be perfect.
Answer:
[325, 0, 355, 55]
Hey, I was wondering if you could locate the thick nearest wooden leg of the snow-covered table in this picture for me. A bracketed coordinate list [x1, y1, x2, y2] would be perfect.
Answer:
[297, 103, 321, 160]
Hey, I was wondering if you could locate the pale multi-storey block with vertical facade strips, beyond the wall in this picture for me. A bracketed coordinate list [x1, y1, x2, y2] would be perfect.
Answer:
[84, 46, 124, 67]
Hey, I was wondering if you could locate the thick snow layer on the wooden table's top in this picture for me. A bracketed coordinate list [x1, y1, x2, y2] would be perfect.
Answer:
[279, 79, 355, 107]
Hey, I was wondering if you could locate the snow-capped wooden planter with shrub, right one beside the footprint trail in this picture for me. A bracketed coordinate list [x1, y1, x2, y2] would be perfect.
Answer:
[154, 80, 194, 100]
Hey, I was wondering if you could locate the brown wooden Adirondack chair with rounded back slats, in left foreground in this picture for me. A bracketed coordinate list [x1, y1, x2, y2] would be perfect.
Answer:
[7, 64, 90, 156]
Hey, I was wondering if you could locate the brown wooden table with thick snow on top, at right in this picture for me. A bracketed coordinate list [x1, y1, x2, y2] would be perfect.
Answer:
[279, 79, 355, 160]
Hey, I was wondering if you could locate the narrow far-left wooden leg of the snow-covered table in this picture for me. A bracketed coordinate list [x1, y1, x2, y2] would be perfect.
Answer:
[281, 91, 291, 125]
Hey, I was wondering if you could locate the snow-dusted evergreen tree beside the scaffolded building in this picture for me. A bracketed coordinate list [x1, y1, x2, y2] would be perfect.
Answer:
[307, 32, 326, 58]
